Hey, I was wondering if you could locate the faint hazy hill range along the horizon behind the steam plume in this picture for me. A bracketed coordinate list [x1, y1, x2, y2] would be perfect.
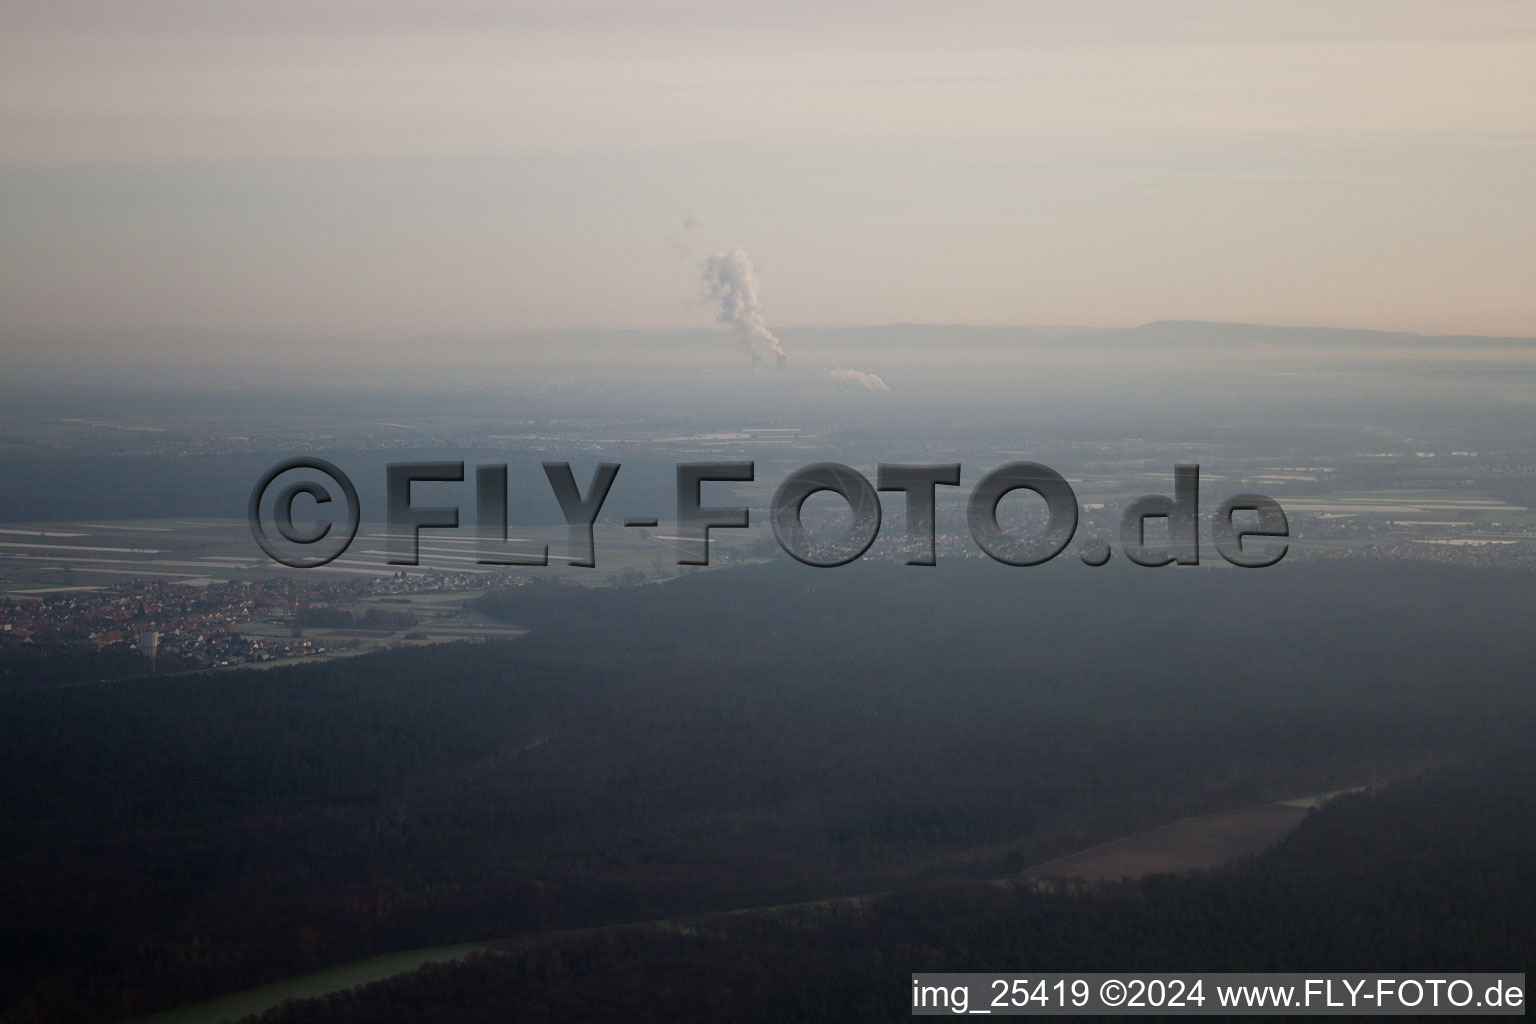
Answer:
[11, 321, 1536, 385]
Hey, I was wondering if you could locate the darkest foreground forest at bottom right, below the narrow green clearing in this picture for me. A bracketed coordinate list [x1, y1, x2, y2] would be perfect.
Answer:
[245, 758, 1536, 1024]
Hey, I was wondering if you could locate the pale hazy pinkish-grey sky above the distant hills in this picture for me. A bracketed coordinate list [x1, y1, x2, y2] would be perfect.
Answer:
[0, 0, 1536, 348]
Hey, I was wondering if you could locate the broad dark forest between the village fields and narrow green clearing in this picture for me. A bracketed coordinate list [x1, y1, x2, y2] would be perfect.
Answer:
[0, 562, 1533, 1021]
